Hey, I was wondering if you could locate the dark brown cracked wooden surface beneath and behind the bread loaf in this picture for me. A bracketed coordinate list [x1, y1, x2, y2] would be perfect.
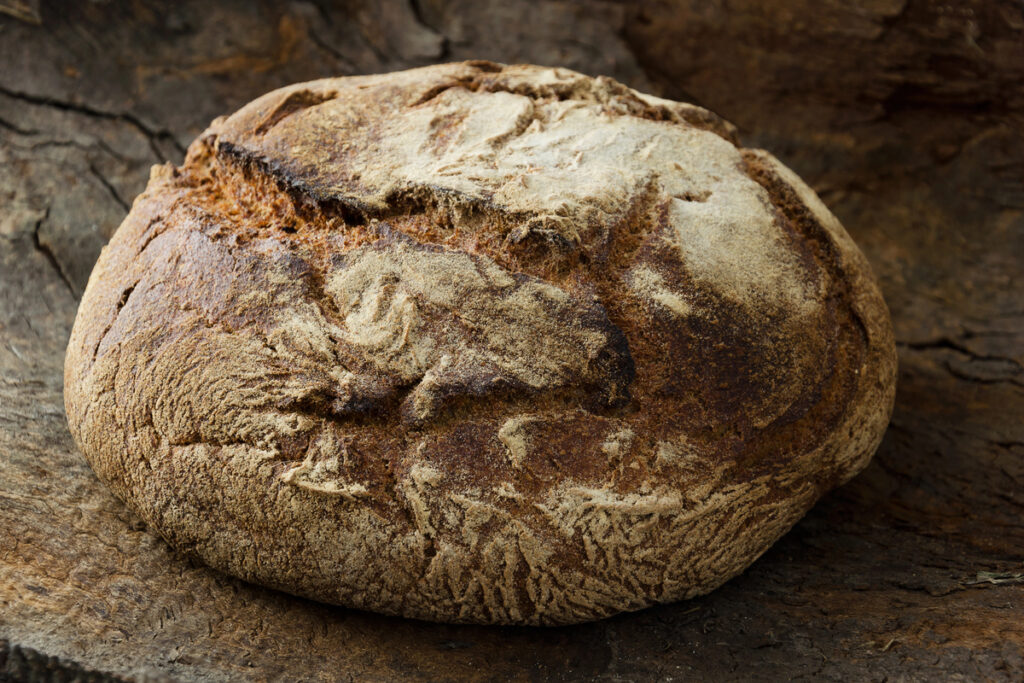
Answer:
[0, 0, 1024, 680]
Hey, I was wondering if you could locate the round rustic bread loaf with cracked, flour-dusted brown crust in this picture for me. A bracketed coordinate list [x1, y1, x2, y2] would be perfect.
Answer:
[65, 62, 896, 625]
